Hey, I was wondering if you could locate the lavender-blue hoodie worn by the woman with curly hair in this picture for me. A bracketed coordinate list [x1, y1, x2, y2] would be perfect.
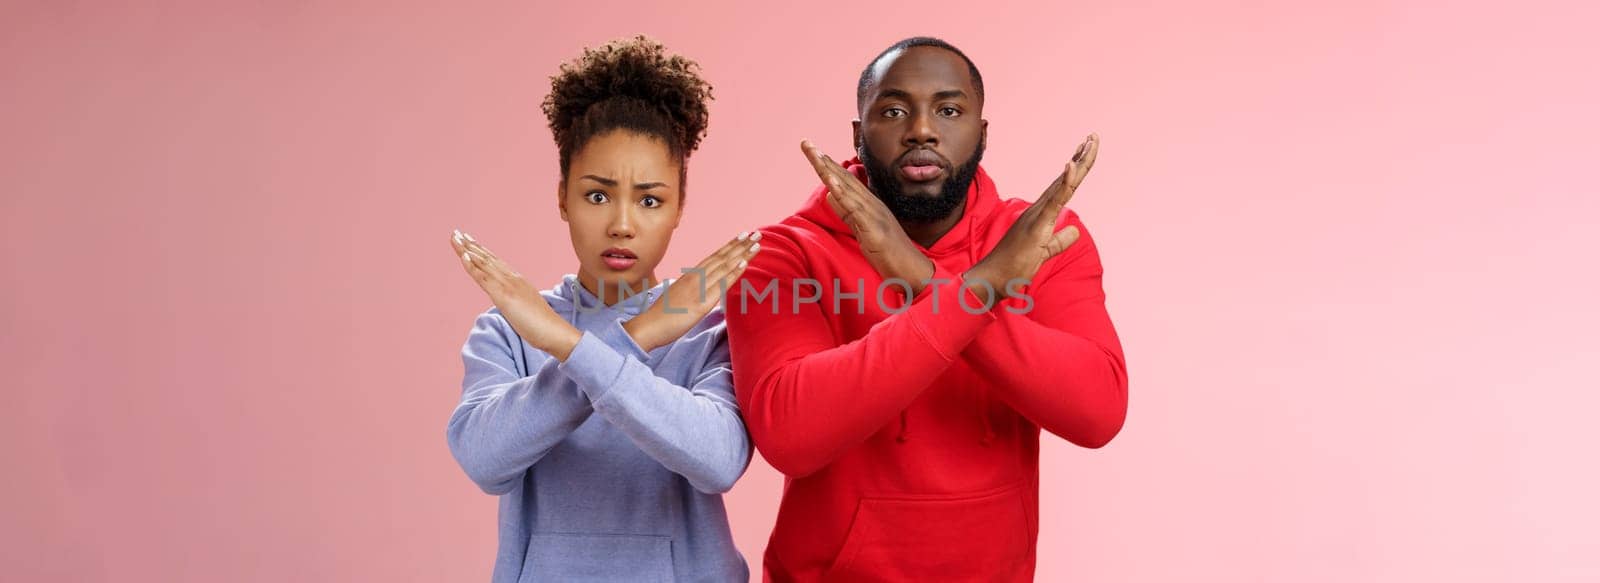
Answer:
[446, 275, 750, 583]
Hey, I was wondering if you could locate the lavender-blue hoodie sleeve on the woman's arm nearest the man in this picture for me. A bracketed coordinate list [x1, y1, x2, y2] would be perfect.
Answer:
[560, 316, 750, 493]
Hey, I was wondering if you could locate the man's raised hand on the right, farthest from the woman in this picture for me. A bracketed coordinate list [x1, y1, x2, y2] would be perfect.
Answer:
[963, 133, 1099, 306]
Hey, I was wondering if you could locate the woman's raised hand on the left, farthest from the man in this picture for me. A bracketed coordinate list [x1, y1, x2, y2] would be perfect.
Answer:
[450, 231, 582, 362]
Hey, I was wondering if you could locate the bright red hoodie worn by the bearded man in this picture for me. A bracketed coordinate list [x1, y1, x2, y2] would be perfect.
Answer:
[726, 160, 1128, 581]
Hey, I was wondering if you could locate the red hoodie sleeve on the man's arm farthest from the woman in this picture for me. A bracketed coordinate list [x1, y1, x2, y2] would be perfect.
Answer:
[962, 213, 1128, 447]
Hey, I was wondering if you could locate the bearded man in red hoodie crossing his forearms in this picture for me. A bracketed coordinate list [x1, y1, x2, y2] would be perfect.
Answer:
[726, 37, 1128, 581]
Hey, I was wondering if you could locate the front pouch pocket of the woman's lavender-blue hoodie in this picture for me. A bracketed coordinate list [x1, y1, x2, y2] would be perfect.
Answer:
[517, 533, 672, 583]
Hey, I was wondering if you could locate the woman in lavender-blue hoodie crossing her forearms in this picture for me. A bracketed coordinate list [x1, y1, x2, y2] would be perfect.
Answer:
[446, 37, 760, 583]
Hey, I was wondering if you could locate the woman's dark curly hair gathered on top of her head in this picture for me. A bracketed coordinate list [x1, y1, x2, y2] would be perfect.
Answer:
[542, 35, 712, 181]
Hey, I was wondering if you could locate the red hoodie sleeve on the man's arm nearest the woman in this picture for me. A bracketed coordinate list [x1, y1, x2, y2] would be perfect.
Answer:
[728, 235, 997, 477]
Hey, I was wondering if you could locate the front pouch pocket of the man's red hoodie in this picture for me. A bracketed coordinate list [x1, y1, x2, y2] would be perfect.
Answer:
[822, 485, 1032, 581]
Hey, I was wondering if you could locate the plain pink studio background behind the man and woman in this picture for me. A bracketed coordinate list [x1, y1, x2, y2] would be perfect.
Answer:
[9, 0, 1600, 581]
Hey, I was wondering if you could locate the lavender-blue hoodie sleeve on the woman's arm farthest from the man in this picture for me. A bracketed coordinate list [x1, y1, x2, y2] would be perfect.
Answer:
[445, 312, 592, 495]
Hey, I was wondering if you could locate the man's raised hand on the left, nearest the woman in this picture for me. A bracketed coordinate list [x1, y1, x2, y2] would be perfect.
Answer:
[800, 141, 933, 300]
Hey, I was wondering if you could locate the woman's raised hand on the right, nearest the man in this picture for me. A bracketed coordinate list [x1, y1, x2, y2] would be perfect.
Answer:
[622, 232, 762, 352]
